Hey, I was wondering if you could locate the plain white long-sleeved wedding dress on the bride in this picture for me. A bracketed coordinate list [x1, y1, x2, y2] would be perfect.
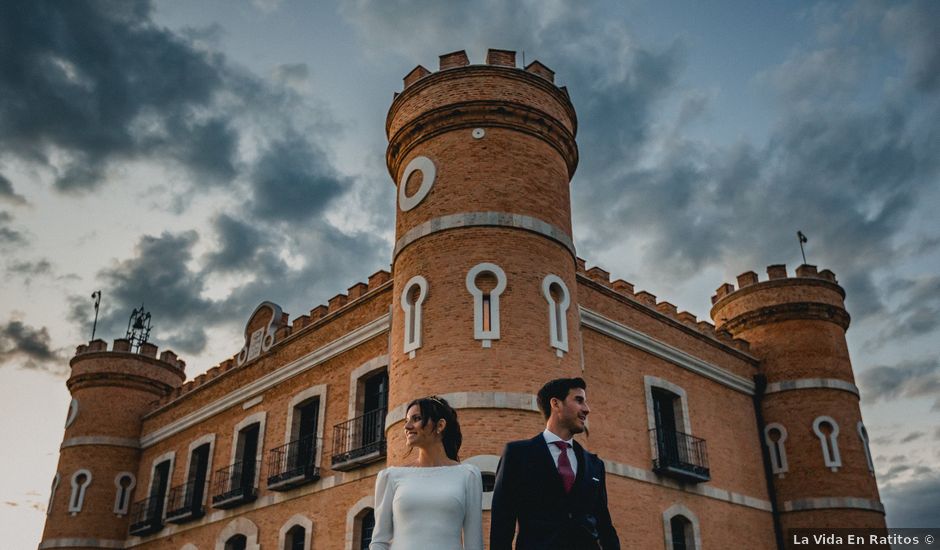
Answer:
[369, 464, 483, 550]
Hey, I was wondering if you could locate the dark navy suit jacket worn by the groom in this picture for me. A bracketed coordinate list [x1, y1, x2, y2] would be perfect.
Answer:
[490, 434, 620, 550]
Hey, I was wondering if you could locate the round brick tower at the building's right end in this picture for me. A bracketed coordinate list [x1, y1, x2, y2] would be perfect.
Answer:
[711, 265, 885, 531]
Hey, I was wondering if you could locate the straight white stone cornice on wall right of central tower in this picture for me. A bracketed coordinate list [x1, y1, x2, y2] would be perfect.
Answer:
[580, 307, 754, 395]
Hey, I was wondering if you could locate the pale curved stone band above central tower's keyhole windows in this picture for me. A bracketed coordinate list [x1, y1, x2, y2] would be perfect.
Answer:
[392, 212, 577, 261]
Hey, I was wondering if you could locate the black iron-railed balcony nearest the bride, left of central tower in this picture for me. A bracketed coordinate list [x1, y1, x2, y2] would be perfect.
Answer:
[331, 408, 386, 471]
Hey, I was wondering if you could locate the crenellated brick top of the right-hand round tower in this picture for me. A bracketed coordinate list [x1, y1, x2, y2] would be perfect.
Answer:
[711, 264, 850, 335]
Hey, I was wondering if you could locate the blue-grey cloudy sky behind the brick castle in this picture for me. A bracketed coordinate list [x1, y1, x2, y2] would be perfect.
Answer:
[0, 0, 940, 548]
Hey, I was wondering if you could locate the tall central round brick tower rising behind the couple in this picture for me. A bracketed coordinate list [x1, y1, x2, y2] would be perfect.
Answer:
[386, 50, 581, 464]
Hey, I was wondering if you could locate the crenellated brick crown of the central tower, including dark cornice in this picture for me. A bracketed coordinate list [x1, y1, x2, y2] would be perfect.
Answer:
[385, 49, 578, 180]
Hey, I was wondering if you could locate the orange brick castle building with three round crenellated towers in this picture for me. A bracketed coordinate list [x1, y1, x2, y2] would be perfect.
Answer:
[39, 50, 884, 550]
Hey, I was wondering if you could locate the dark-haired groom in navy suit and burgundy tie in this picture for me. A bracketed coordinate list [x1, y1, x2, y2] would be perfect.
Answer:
[490, 378, 620, 550]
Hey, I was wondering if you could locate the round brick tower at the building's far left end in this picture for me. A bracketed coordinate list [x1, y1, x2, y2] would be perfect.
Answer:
[39, 339, 186, 548]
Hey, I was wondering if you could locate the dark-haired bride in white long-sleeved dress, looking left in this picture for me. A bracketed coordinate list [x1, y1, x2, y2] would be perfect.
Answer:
[369, 396, 483, 550]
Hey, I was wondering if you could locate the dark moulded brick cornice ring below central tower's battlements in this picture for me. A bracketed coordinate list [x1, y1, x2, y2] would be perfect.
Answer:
[385, 100, 578, 180]
